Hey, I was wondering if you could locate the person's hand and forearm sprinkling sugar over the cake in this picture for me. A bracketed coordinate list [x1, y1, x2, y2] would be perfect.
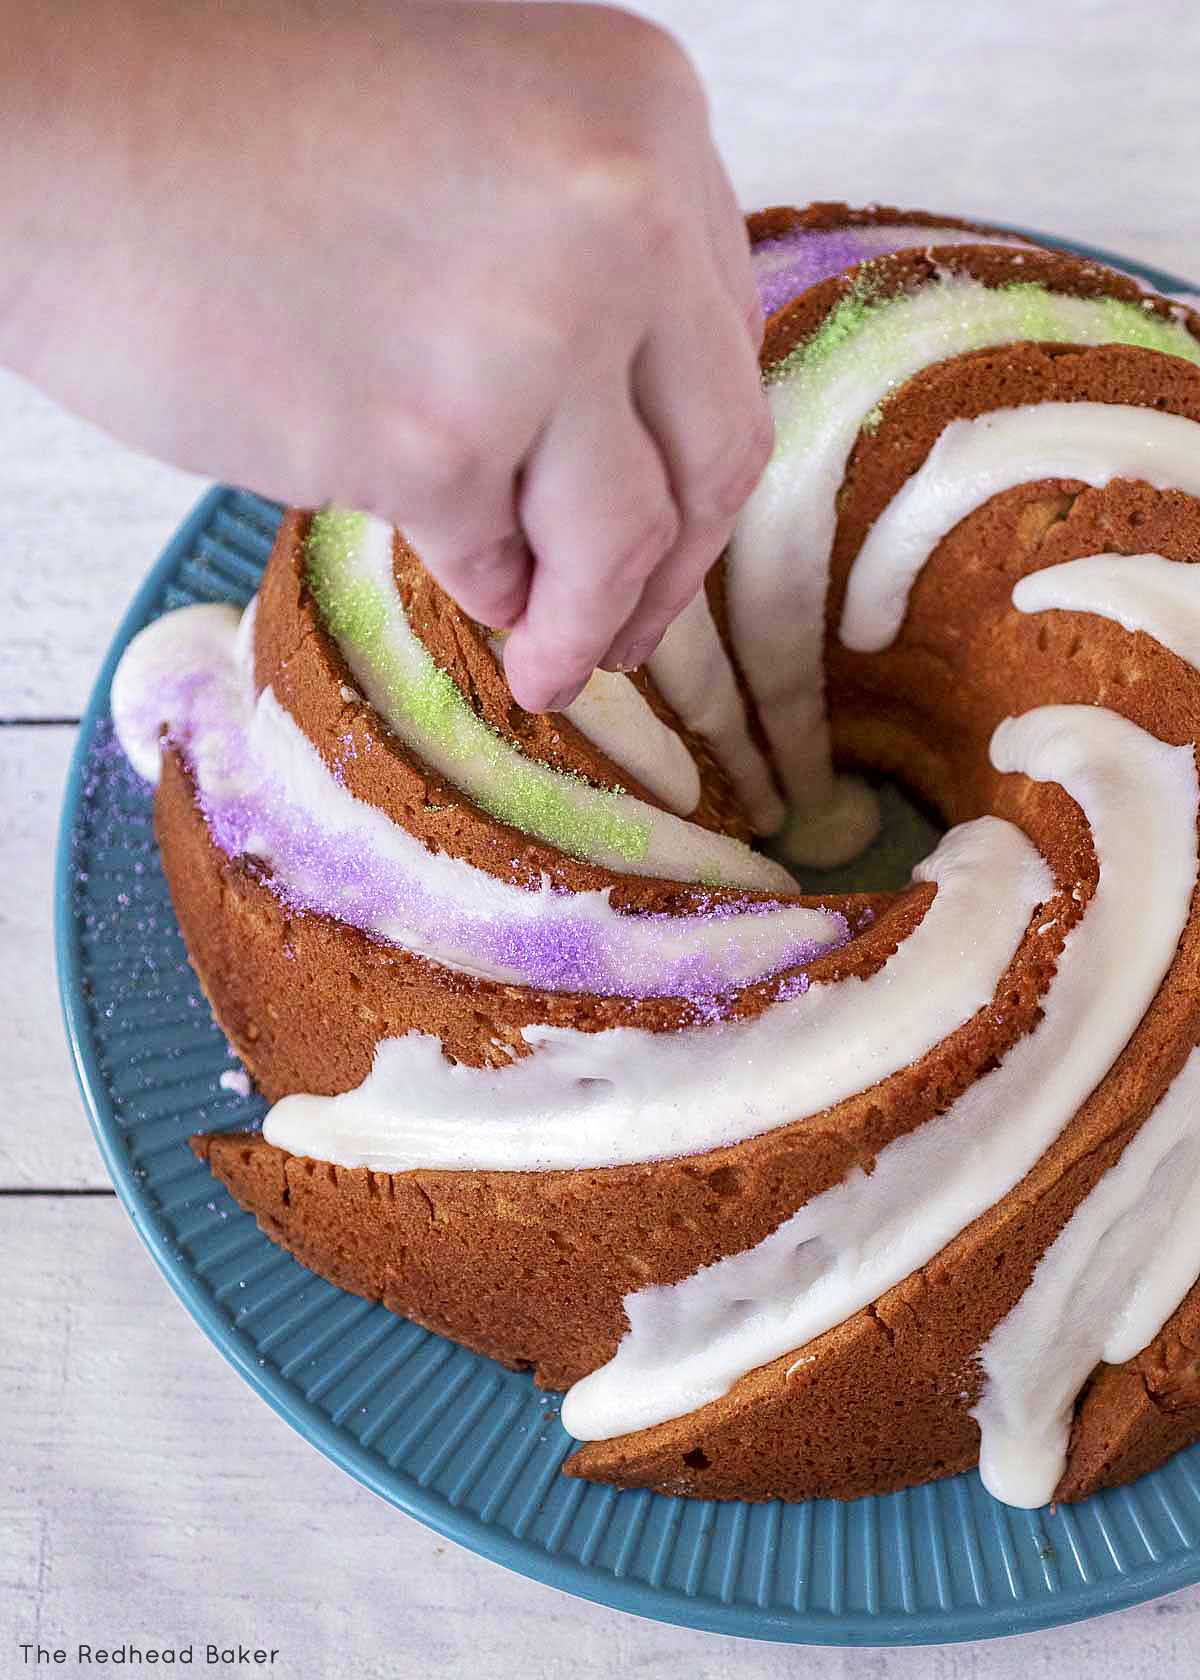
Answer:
[0, 0, 771, 711]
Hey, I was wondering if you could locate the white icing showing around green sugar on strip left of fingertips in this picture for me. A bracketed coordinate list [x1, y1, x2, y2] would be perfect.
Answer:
[317, 514, 795, 894]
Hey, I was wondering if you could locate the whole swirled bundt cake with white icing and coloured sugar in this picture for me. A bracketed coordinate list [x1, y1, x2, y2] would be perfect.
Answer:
[113, 205, 1200, 1505]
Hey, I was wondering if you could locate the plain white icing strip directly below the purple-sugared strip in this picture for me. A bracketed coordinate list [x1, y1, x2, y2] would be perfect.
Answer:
[264, 816, 1054, 1173]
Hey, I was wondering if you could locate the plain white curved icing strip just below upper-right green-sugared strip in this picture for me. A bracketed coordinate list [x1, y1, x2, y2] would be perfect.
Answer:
[839, 403, 1200, 654]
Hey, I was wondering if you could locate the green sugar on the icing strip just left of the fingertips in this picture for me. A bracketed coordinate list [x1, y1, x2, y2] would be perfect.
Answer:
[304, 507, 650, 864]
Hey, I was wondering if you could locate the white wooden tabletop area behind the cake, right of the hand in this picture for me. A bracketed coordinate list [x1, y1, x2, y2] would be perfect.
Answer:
[635, 0, 1200, 279]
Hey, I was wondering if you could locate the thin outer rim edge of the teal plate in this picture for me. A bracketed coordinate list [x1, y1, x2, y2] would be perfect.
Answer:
[54, 228, 1200, 1646]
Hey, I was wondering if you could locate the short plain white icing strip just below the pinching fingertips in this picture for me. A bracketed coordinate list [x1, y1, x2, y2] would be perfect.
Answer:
[487, 635, 701, 816]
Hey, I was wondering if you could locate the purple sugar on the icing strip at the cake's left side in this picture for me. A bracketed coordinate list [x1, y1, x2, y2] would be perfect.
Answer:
[126, 651, 849, 994]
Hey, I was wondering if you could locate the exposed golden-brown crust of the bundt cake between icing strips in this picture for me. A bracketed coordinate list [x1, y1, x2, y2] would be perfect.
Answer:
[170, 230, 1200, 1499]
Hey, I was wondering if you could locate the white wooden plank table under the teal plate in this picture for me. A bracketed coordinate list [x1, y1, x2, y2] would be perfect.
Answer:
[0, 0, 1200, 1680]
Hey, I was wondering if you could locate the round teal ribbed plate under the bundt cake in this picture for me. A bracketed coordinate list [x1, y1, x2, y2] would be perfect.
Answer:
[57, 243, 1200, 1645]
